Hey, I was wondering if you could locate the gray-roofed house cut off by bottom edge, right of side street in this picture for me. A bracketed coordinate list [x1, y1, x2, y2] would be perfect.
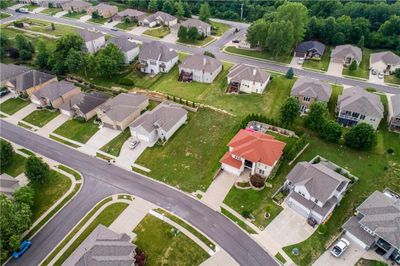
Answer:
[63, 224, 136, 266]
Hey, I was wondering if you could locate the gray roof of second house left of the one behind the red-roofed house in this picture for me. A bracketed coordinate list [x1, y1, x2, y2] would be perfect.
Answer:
[139, 41, 178, 62]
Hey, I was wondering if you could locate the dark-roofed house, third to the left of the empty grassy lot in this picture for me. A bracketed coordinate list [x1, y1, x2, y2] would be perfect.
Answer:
[60, 92, 110, 120]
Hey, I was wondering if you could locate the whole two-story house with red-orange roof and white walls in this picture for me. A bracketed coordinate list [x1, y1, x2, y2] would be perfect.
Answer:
[220, 129, 286, 177]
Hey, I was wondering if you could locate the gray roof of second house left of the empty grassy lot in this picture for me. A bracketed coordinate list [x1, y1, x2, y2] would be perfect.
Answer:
[99, 93, 148, 122]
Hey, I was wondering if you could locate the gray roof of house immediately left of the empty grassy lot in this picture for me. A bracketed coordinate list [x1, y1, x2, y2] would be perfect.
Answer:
[130, 101, 187, 133]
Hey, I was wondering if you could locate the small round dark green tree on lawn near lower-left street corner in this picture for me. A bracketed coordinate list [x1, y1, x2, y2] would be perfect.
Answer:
[25, 156, 50, 184]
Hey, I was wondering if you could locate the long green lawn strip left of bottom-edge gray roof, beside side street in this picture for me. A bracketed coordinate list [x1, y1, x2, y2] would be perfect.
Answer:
[54, 202, 128, 265]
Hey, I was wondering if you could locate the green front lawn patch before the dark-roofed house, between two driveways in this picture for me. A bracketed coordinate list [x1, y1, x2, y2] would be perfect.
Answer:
[54, 118, 99, 143]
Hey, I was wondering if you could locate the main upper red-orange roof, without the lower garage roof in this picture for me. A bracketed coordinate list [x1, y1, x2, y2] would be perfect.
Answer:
[223, 129, 286, 166]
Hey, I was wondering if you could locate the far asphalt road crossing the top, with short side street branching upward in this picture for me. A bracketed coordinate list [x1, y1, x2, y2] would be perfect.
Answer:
[0, 10, 400, 94]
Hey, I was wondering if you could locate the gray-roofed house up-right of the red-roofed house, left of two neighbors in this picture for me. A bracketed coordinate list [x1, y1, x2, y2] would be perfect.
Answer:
[290, 77, 332, 113]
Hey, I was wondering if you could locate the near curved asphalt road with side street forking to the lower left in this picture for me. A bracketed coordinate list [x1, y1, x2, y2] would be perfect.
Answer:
[0, 121, 278, 265]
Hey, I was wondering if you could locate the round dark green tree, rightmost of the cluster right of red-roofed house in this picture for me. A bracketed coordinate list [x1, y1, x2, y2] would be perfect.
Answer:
[344, 123, 376, 150]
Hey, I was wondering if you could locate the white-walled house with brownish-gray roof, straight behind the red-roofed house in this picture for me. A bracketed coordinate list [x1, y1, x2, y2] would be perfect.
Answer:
[227, 64, 271, 93]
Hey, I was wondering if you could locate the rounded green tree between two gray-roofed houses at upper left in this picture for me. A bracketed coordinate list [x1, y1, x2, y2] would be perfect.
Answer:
[95, 43, 124, 78]
